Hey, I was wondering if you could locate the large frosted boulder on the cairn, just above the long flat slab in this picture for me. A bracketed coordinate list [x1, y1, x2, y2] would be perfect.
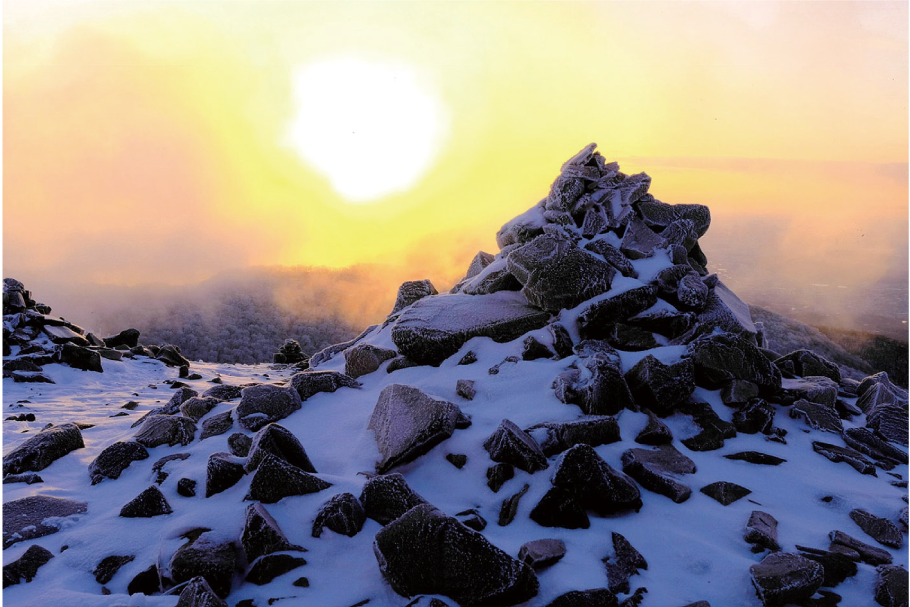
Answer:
[506, 234, 616, 312]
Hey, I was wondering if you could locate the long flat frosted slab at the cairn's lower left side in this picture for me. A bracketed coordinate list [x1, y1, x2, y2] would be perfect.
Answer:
[392, 292, 550, 365]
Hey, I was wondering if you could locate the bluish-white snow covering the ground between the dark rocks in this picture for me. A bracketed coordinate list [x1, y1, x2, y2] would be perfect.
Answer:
[3, 340, 907, 607]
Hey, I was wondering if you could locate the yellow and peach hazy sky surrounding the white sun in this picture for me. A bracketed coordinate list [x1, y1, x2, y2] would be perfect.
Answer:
[3, 0, 908, 284]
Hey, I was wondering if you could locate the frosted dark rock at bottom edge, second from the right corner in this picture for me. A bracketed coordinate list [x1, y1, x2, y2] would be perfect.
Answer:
[749, 552, 824, 607]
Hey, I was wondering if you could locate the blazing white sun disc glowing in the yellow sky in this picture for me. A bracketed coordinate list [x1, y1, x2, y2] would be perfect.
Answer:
[290, 59, 448, 203]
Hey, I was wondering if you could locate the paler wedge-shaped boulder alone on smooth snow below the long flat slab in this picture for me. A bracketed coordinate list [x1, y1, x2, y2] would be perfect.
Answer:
[367, 384, 466, 474]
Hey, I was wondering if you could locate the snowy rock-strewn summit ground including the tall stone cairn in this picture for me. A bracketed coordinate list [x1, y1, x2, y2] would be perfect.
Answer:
[3, 144, 910, 607]
